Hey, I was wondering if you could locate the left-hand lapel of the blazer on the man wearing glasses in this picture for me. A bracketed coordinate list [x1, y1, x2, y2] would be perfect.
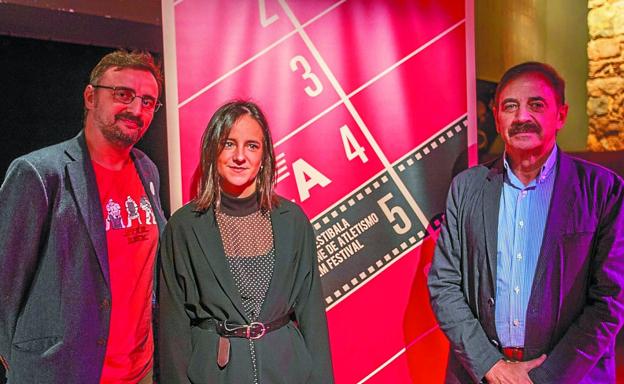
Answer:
[65, 131, 110, 287]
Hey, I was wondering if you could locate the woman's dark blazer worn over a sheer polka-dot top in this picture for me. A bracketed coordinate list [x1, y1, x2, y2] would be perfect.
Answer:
[159, 199, 333, 384]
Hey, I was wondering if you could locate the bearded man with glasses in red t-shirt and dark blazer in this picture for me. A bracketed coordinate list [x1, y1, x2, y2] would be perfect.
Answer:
[0, 51, 164, 384]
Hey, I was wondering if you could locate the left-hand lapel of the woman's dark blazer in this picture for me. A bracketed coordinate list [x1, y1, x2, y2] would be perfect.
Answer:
[193, 209, 250, 322]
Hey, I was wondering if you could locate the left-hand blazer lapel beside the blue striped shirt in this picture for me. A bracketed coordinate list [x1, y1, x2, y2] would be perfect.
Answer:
[483, 157, 504, 295]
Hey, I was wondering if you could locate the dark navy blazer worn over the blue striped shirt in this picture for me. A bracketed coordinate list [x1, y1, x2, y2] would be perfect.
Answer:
[429, 151, 624, 384]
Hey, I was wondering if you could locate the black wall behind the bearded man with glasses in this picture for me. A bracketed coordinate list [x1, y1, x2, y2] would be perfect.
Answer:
[0, 36, 170, 214]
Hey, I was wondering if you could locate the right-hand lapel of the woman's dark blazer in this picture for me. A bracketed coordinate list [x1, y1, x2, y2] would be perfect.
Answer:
[259, 205, 295, 321]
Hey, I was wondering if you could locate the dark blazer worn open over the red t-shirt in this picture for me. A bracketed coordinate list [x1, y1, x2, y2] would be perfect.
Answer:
[0, 132, 164, 384]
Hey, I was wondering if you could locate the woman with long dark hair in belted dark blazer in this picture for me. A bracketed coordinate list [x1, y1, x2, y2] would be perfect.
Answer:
[159, 101, 333, 384]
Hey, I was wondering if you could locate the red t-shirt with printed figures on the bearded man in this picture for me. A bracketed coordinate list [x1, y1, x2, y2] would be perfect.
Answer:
[92, 161, 159, 384]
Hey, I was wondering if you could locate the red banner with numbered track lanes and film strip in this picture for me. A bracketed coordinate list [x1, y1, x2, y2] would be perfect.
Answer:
[163, 0, 476, 384]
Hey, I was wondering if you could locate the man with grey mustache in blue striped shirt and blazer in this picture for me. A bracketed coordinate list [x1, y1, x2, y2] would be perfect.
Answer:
[428, 62, 624, 384]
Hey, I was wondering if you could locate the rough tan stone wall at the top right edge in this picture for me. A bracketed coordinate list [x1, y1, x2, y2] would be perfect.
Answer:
[587, 0, 624, 151]
